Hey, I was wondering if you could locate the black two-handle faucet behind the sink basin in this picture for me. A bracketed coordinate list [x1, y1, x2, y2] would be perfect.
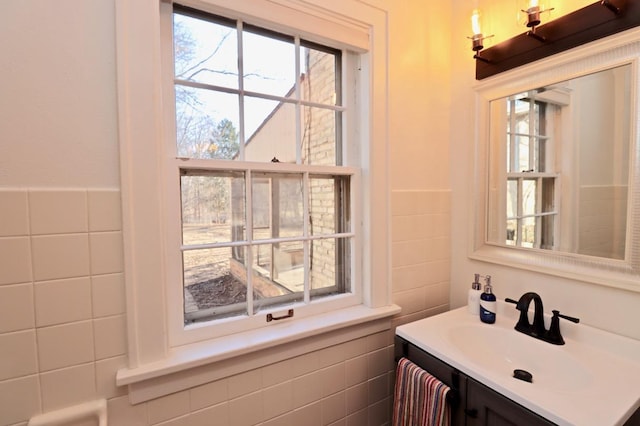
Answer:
[505, 292, 580, 345]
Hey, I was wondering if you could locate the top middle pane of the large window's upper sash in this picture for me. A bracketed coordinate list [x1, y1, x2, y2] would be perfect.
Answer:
[242, 30, 296, 97]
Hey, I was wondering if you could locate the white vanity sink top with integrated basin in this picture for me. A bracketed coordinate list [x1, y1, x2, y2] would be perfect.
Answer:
[396, 301, 640, 426]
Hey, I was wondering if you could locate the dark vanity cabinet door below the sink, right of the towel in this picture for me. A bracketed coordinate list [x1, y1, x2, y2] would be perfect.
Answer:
[465, 378, 554, 426]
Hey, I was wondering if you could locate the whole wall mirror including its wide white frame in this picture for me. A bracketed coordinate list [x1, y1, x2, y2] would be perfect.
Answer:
[469, 29, 640, 292]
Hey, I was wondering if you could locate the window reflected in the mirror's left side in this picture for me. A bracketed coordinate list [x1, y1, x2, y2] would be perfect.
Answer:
[506, 91, 559, 249]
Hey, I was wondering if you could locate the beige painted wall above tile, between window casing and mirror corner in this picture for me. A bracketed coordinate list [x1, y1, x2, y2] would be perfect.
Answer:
[385, 0, 452, 190]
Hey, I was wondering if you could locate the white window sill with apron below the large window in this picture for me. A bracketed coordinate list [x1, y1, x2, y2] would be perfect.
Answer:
[116, 305, 400, 404]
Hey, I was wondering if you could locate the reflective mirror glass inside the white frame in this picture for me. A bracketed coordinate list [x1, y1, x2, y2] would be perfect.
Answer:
[487, 64, 632, 259]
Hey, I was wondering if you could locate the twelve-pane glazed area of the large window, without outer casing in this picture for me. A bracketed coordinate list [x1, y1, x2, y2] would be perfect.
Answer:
[167, 5, 357, 326]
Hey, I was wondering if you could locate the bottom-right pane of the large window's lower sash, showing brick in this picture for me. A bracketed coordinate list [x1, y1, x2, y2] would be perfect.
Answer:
[309, 238, 351, 299]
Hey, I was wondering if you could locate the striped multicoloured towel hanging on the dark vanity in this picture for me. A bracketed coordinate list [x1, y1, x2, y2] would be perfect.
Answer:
[391, 358, 451, 426]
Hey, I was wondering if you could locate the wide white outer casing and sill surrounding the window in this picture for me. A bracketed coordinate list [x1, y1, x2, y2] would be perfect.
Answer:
[116, 0, 399, 403]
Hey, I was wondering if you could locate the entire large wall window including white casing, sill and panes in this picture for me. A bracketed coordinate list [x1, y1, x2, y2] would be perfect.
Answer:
[116, 0, 392, 396]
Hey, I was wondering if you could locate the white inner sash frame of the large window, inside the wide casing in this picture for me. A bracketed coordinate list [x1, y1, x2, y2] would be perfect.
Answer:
[161, 7, 362, 346]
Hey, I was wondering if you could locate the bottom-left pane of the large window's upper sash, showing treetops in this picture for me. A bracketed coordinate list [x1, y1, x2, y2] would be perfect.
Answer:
[175, 85, 240, 160]
